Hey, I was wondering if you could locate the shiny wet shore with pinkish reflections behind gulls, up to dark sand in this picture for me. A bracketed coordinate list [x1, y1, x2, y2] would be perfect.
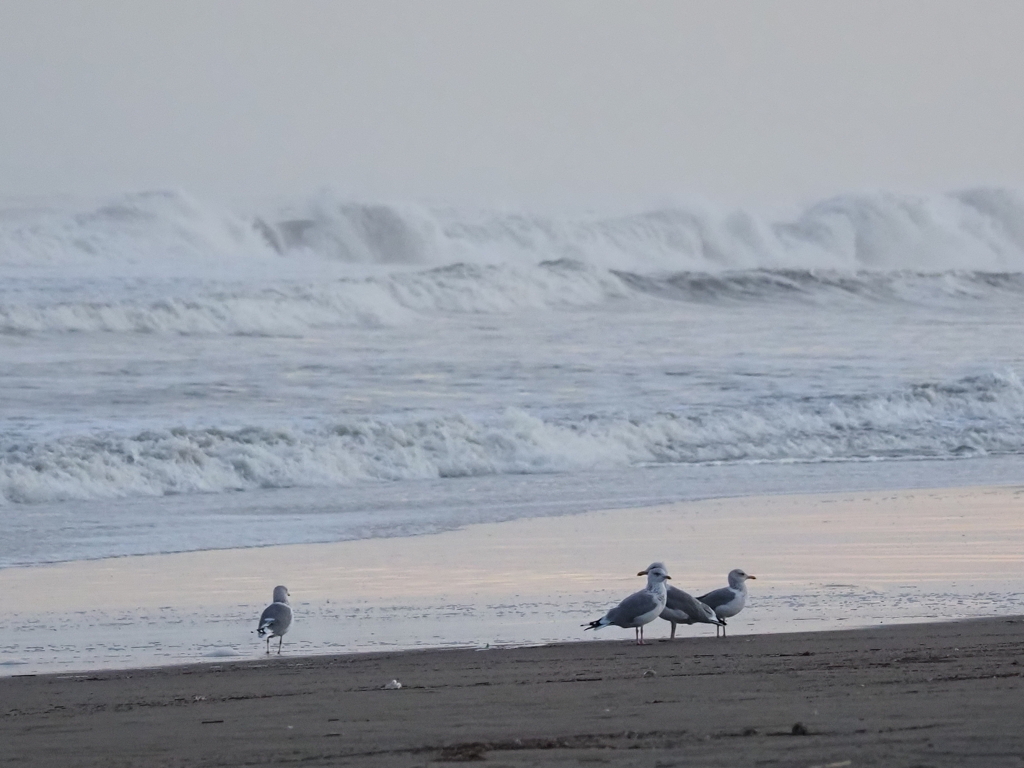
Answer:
[0, 485, 1024, 676]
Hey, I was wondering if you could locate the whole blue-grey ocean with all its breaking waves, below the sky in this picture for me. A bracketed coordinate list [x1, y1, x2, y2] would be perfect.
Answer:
[0, 189, 1024, 567]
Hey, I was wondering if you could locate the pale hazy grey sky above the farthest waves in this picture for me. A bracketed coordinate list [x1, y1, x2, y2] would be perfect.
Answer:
[0, 0, 1024, 206]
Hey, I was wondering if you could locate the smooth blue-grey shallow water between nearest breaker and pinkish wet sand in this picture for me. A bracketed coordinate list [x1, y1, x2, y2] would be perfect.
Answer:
[9, 457, 1024, 569]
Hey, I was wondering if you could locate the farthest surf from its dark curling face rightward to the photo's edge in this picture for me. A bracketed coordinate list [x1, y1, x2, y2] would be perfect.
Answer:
[251, 189, 1024, 272]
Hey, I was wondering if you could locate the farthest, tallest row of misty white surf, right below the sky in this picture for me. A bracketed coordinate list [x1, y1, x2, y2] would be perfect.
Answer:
[6, 189, 1024, 273]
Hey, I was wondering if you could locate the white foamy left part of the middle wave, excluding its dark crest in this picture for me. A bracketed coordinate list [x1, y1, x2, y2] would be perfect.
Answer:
[0, 262, 630, 336]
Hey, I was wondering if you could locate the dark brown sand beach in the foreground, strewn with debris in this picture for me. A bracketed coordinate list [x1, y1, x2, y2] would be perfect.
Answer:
[0, 617, 1024, 768]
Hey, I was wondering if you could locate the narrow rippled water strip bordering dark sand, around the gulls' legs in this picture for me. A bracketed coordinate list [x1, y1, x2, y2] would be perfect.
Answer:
[0, 585, 1024, 676]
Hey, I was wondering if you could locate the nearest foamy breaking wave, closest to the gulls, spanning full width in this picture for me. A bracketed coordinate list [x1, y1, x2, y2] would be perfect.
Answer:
[0, 372, 1024, 504]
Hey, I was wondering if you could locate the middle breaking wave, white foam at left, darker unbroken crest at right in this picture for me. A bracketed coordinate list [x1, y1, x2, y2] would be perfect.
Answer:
[0, 259, 1024, 336]
